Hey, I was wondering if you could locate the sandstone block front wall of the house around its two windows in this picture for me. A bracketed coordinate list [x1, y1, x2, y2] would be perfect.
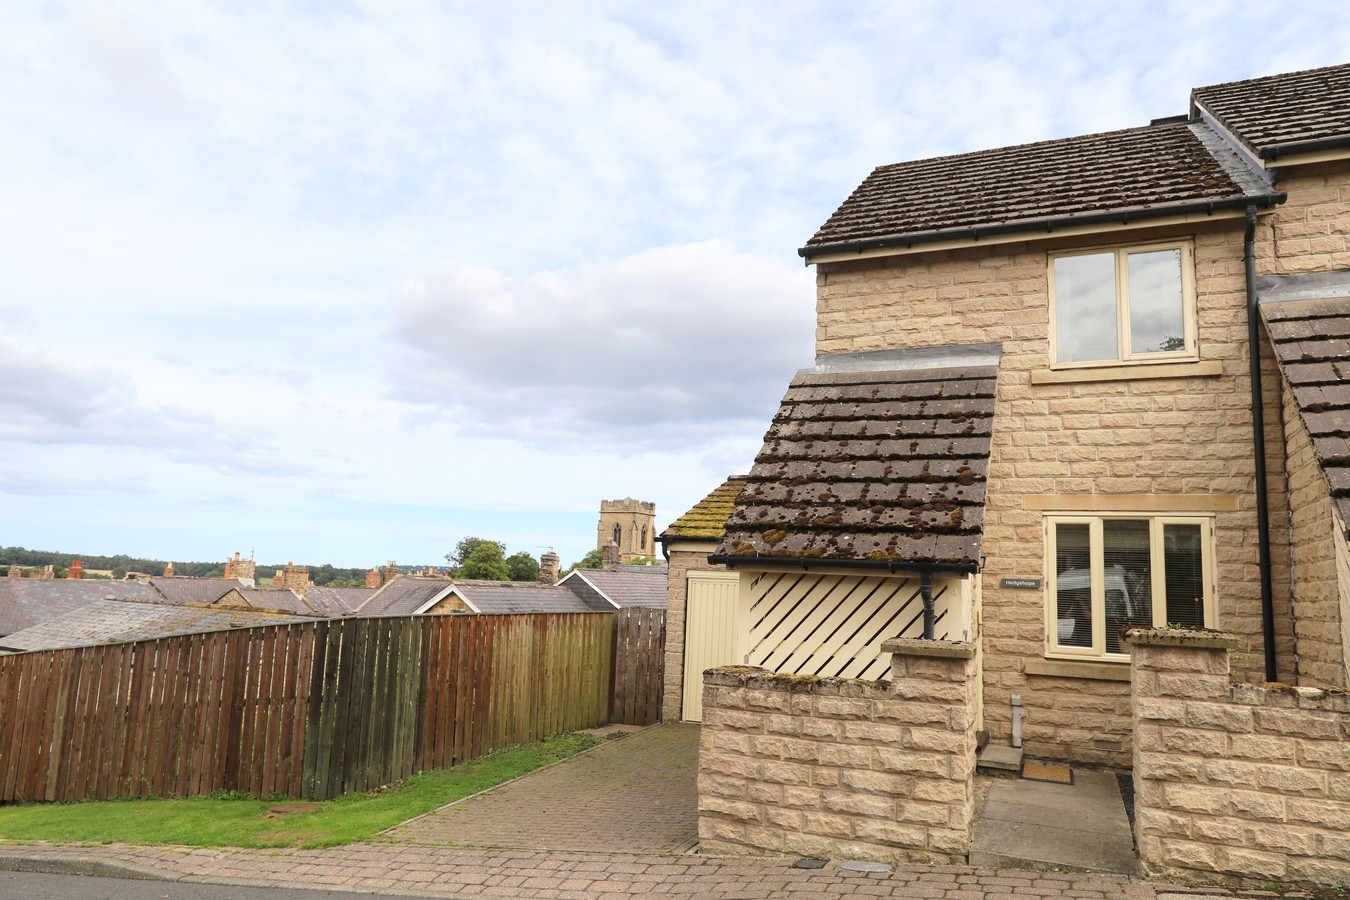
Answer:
[817, 219, 1293, 768]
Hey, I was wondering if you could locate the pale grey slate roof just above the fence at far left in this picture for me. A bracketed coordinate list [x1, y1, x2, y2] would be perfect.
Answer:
[0, 600, 311, 650]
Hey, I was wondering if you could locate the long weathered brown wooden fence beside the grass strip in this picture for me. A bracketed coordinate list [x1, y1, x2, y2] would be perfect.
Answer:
[0, 610, 664, 801]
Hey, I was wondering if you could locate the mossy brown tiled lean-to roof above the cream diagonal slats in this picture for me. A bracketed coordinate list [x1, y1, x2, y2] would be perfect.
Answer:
[710, 344, 1000, 569]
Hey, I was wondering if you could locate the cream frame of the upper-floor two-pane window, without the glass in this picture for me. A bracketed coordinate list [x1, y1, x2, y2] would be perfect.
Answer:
[1046, 240, 1200, 370]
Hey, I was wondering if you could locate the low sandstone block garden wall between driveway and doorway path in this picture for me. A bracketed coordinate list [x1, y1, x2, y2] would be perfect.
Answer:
[698, 641, 977, 864]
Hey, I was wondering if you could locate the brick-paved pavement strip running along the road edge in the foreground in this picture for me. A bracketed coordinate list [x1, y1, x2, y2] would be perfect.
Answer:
[0, 845, 1225, 900]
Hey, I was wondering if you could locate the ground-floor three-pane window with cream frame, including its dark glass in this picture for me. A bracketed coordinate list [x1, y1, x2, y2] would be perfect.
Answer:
[1045, 514, 1215, 660]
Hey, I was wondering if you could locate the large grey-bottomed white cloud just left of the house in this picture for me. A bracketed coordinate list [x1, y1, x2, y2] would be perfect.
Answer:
[393, 242, 814, 449]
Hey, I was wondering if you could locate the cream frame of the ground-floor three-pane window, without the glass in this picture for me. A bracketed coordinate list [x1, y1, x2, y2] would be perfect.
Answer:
[1042, 513, 1218, 663]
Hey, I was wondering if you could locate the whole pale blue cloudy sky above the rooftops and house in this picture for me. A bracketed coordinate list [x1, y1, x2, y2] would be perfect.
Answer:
[0, 0, 1350, 567]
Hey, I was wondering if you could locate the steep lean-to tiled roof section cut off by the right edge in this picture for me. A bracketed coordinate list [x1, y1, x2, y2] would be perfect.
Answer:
[1257, 273, 1350, 525]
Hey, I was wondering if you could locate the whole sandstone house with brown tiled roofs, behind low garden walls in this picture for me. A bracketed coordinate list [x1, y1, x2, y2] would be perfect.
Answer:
[702, 66, 1350, 766]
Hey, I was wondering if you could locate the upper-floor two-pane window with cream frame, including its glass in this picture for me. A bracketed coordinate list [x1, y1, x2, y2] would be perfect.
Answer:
[1049, 243, 1199, 368]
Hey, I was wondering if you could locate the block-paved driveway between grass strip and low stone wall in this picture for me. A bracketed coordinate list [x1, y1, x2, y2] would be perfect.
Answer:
[383, 725, 698, 853]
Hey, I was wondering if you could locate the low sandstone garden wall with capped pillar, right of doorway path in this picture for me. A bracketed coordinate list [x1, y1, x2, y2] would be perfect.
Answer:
[1131, 629, 1350, 885]
